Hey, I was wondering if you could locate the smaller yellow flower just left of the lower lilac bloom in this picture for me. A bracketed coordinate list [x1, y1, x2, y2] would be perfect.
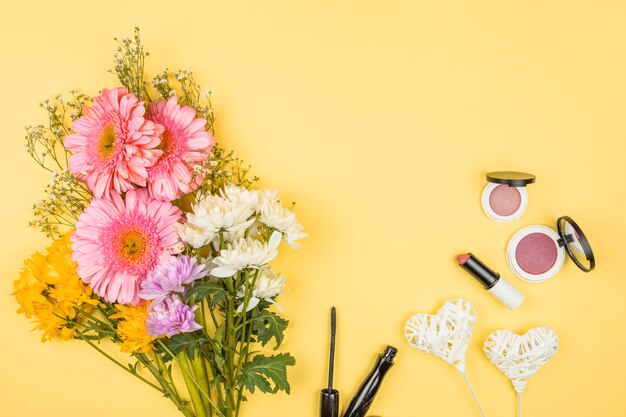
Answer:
[110, 303, 154, 353]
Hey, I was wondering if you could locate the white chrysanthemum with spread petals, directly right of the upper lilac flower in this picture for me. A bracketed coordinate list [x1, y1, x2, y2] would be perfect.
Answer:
[211, 231, 282, 278]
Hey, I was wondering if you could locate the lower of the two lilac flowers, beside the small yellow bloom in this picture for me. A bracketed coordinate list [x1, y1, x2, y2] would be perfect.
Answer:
[146, 295, 202, 337]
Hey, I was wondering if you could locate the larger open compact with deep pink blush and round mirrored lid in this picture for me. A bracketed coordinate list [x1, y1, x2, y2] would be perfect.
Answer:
[506, 216, 596, 282]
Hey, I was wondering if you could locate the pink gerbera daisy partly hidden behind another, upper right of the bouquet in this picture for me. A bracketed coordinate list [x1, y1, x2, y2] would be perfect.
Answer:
[148, 97, 215, 201]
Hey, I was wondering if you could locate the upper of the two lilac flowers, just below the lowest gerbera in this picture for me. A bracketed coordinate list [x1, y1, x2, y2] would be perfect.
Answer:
[139, 256, 208, 300]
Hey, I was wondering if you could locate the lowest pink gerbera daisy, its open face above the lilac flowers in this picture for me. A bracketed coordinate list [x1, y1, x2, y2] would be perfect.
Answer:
[71, 189, 181, 304]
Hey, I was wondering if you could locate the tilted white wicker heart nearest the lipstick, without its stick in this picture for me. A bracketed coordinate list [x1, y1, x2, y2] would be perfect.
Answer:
[404, 298, 476, 374]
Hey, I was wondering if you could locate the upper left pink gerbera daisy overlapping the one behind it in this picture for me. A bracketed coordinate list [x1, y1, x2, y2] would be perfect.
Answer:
[64, 88, 163, 198]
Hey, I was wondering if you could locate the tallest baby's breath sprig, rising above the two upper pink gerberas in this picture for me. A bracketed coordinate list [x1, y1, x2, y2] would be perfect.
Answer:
[107, 27, 150, 101]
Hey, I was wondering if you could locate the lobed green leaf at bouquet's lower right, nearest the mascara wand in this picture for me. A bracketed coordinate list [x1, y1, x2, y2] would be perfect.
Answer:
[238, 353, 296, 394]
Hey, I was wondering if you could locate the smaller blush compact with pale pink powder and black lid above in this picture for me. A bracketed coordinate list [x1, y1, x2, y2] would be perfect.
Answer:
[481, 171, 535, 222]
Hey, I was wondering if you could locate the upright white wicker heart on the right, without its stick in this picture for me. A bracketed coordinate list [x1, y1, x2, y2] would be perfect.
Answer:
[484, 327, 559, 395]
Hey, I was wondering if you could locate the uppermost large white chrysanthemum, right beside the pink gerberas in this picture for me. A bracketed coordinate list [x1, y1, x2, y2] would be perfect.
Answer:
[187, 195, 255, 233]
